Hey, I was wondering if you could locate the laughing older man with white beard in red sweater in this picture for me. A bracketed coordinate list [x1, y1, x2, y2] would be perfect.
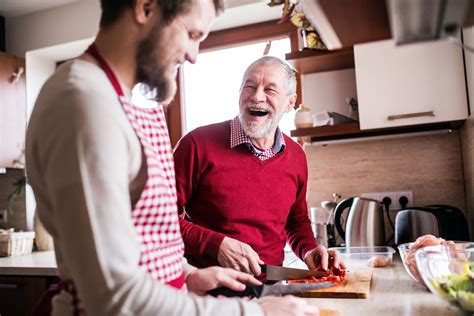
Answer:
[174, 57, 344, 275]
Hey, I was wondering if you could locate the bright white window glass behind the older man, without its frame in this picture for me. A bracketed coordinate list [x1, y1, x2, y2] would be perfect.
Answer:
[182, 37, 295, 135]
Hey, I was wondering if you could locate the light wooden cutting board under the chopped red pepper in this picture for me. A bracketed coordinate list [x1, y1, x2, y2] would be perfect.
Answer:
[293, 270, 372, 298]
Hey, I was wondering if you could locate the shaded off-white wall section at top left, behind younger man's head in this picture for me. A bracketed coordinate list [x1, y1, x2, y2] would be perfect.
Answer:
[5, 0, 100, 57]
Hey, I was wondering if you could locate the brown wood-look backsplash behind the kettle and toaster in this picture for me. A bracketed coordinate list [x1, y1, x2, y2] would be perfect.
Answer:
[305, 130, 466, 235]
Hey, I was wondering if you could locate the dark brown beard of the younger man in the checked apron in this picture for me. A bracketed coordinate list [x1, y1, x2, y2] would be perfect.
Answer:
[135, 27, 176, 103]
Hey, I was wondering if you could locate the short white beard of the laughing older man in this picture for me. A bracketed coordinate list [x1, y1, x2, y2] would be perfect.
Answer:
[239, 103, 285, 138]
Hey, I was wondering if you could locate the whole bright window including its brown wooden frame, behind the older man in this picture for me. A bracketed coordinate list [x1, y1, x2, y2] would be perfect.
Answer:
[167, 21, 301, 146]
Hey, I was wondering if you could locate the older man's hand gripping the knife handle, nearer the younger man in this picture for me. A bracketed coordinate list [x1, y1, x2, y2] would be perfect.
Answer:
[217, 237, 264, 275]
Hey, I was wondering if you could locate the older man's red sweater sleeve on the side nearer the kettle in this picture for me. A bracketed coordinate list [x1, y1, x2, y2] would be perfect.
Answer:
[285, 147, 317, 259]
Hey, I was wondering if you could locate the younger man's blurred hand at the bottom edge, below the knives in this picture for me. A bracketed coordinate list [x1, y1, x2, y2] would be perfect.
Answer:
[257, 295, 319, 316]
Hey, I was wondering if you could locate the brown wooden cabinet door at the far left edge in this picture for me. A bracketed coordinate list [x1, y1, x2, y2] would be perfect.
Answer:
[0, 53, 26, 167]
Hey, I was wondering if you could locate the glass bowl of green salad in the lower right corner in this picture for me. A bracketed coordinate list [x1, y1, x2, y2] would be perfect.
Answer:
[415, 242, 474, 313]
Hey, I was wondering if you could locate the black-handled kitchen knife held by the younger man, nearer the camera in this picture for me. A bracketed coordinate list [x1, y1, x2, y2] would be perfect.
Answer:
[207, 282, 336, 298]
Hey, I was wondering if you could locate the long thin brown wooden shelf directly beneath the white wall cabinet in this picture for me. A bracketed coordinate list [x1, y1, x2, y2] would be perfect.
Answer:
[291, 121, 464, 141]
